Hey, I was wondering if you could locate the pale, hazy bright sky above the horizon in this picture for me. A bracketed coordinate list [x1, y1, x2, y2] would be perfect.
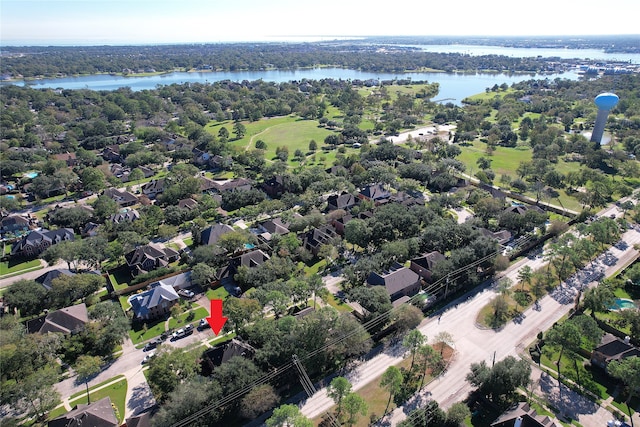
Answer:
[0, 0, 640, 45]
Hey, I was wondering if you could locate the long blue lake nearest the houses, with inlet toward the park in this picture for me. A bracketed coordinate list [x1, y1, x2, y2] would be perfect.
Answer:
[3, 68, 578, 105]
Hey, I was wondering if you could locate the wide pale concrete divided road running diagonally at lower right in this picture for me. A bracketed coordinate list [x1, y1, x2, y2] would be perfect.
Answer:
[301, 230, 640, 425]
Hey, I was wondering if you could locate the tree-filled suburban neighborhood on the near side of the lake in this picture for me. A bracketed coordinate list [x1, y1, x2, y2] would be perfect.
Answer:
[0, 36, 640, 427]
